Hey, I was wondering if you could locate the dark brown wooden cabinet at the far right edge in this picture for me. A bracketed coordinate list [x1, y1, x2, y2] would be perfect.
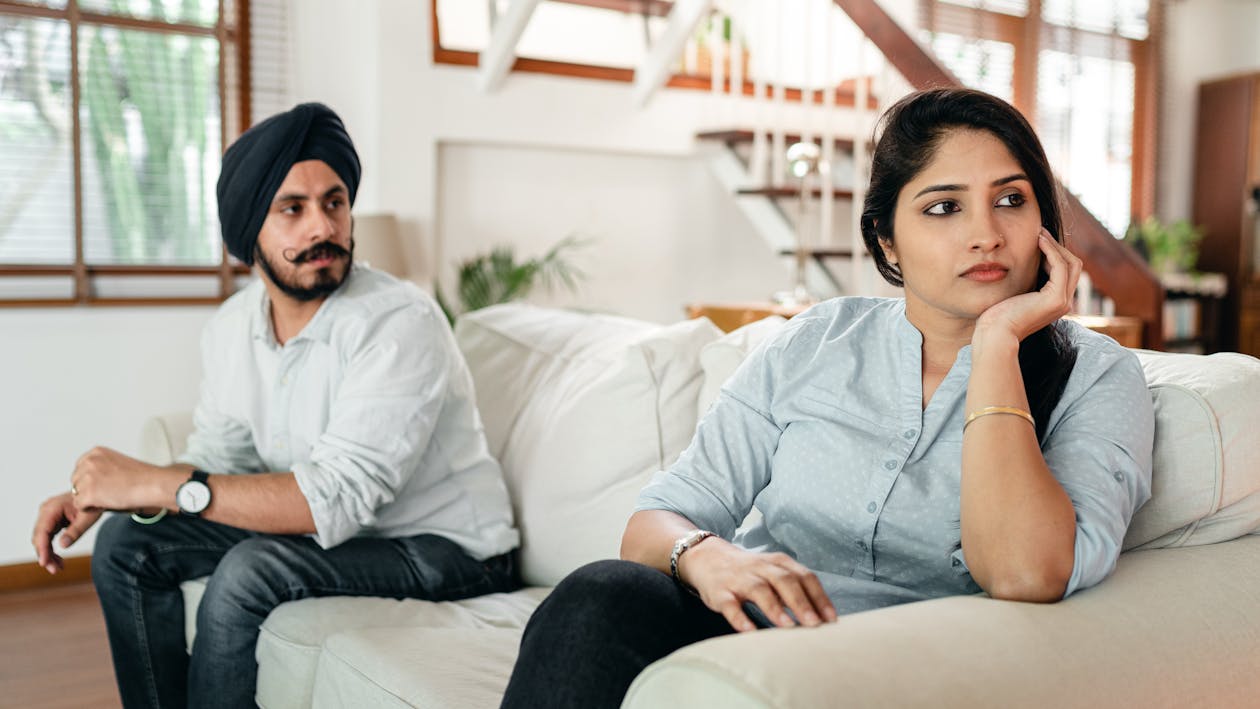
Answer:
[1192, 73, 1260, 356]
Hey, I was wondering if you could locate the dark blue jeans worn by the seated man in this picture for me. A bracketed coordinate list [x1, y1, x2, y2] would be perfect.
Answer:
[92, 515, 519, 708]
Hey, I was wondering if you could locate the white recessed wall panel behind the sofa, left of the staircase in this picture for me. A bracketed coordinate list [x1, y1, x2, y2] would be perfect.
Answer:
[437, 144, 791, 322]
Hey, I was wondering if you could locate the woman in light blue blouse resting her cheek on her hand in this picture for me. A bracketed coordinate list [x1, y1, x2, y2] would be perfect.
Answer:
[504, 89, 1154, 706]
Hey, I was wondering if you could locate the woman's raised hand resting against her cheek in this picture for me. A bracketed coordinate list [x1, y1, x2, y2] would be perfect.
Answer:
[971, 228, 1082, 345]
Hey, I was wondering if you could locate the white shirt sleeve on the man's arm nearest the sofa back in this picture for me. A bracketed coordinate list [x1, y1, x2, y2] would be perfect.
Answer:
[294, 307, 457, 549]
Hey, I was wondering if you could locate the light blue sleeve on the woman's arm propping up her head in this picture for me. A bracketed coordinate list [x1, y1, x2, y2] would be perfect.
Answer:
[1043, 348, 1155, 597]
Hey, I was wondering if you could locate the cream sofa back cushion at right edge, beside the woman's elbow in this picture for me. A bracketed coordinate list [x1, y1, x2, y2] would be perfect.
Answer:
[1124, 350, 1260, 549]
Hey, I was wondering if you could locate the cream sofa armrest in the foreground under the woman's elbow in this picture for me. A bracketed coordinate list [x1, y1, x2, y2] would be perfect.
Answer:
[622, 535, 1260, 709]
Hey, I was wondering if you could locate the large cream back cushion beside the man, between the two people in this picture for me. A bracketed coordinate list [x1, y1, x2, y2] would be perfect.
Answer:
[456, 303, 721, 586]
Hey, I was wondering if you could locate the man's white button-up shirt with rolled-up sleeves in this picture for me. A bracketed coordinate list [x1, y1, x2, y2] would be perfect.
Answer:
[179, 266, 519, 559]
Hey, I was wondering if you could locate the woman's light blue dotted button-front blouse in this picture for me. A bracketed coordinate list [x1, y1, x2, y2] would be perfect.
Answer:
[636, 297, 1154, 613]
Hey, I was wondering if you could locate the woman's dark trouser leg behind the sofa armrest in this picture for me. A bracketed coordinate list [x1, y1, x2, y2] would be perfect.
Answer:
[503, 560, 735, 709]
